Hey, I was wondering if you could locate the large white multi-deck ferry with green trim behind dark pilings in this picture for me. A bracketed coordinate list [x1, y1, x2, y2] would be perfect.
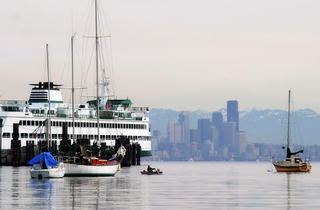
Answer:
[0, 82, 151, 156]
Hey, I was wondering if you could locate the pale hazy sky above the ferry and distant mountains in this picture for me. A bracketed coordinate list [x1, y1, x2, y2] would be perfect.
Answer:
[0, 0, 320, 112]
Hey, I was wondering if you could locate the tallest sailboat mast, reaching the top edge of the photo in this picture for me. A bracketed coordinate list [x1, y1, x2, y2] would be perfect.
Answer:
[94, 0, 100, 145]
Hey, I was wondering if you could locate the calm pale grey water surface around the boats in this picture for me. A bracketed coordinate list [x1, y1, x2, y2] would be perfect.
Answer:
[0, 162, 320, 209]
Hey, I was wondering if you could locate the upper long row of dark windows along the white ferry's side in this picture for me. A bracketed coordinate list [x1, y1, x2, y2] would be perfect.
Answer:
[19, 120, 147, 129]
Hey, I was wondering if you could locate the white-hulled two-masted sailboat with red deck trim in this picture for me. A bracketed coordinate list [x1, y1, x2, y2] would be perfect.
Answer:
[65, 0, 124, 176]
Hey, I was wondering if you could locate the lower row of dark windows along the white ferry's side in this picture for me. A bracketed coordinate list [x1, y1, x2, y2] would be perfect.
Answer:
[2, 133, 150, 140]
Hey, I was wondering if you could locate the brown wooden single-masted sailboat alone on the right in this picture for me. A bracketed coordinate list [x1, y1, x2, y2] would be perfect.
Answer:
[272, 90, 312, 172]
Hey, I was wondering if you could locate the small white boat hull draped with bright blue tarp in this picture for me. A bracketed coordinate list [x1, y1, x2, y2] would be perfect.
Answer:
[28, 152, 65, 179]
